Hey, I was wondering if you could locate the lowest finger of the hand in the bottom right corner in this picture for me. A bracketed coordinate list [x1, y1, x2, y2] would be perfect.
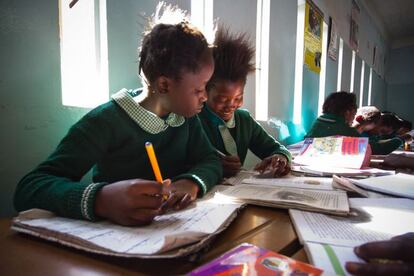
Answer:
[345, 262, 414, 275]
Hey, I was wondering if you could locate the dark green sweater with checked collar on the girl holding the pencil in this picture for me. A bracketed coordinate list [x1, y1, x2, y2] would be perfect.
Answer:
[14, 89, 222, 220]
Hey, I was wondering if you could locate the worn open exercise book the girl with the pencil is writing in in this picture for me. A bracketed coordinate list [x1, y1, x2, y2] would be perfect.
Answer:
[12, 198, 242, 258]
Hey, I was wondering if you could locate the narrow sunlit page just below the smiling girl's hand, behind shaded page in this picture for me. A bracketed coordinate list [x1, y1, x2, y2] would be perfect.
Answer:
[242, 175, 333, 190]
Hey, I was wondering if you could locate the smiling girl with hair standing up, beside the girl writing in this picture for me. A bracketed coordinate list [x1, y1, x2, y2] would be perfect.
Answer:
[199, 28, 291, 177]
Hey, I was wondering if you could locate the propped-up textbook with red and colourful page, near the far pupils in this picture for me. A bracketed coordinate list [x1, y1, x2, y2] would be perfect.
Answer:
[293, 136, 369, 169]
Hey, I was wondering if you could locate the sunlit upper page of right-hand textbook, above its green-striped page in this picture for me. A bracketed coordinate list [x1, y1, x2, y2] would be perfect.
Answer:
[289, 198, 414, 247]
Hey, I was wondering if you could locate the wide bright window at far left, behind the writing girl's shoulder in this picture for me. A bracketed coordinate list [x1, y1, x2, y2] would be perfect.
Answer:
[59, 0, 109, 107]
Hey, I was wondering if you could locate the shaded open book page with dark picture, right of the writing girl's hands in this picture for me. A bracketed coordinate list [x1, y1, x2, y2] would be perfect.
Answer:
[215, 184, 349, 215]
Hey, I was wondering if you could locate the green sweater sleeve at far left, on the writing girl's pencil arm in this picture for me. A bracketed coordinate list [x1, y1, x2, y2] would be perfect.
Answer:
[14, 111, 111, 220]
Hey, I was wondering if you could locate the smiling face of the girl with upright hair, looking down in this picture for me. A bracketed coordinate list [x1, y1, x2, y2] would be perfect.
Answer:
[207, 80, 245, 122]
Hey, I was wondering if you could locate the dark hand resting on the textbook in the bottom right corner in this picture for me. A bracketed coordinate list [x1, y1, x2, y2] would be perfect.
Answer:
[345, 233, 414, 276]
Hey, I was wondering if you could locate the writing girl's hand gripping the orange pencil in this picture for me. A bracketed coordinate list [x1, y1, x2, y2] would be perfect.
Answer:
[95, 179, 163, 226]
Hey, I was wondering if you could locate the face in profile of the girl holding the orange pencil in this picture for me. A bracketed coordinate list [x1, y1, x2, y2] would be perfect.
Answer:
[168, 59, 214, 118]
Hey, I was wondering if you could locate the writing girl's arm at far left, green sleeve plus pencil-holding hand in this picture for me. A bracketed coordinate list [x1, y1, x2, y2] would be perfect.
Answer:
[14, 104, 161, 224]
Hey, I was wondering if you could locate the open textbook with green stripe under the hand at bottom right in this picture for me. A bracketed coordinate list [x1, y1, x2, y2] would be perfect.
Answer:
[289, 198, 414, 275]
